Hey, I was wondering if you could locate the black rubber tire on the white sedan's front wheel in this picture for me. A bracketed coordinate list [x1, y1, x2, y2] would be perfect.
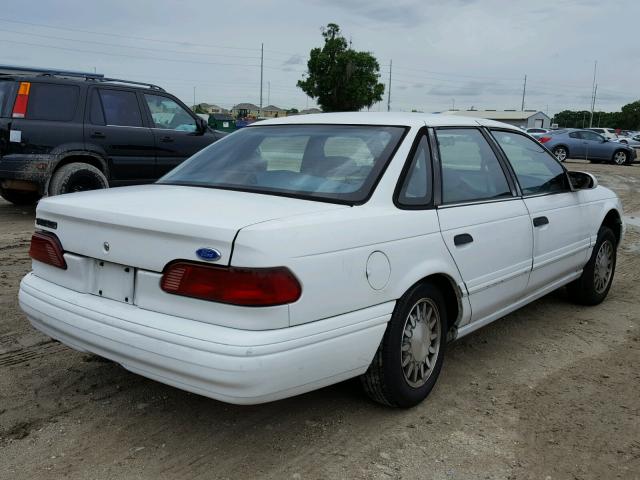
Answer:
[567, 226, 618, 305]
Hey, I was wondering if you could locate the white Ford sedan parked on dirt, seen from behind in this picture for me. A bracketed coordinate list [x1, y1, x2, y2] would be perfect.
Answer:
[20, 113, 623, 407]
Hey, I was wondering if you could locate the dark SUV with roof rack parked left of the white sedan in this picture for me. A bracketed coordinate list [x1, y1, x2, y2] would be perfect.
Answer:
[0, 66, 225, 204]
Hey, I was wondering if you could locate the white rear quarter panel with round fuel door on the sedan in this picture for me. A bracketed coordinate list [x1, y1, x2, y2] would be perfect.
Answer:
[231, 206, 464, 325]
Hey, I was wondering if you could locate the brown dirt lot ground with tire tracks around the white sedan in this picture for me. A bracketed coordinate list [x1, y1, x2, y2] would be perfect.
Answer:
[0, 162, 640, 480]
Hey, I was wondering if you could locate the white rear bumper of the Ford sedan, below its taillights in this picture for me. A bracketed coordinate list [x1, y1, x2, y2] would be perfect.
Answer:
[19, 273, 394, 404]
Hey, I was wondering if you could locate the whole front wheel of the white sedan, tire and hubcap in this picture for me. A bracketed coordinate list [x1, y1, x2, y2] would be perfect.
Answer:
[567, 227, 617, 305]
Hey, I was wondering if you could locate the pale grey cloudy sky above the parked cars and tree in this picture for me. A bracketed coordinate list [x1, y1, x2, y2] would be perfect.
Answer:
[0, 0, 640, 115]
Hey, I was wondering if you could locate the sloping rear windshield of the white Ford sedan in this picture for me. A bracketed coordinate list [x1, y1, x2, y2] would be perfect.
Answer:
[158, 125, 405, 203]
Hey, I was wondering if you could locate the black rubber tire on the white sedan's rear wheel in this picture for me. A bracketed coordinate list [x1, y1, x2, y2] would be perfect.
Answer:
[360, 283, 447, 408]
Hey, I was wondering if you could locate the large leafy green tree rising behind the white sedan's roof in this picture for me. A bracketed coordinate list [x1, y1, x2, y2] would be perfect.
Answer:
[298, 23, 384, 112]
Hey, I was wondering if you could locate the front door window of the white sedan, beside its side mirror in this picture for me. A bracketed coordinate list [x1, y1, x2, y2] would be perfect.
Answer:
[492, 130, 568, 195]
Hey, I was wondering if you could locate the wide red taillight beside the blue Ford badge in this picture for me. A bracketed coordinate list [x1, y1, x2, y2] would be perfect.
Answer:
[160, 262, 302, 307]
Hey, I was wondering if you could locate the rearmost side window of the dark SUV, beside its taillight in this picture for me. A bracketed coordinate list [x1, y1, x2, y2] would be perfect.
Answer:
[26, 83, 80, 122]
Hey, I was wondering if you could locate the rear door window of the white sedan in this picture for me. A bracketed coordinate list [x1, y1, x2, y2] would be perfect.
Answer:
[436, 128, 511, 203]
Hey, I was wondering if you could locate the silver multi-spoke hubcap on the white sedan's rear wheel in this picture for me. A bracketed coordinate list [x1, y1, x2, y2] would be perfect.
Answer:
[400, 298, 441, 388]
